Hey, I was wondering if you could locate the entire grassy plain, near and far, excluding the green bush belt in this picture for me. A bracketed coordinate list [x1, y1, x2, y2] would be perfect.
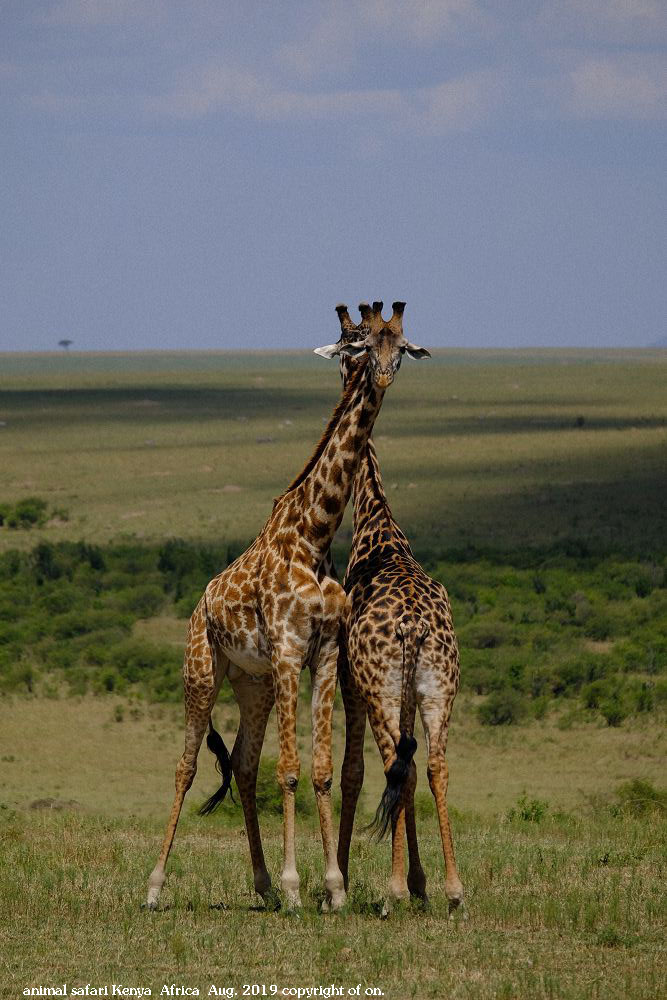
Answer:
[0, 351, 667, 1000]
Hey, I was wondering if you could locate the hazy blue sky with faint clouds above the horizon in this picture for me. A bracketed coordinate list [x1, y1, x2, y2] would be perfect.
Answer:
[0, 0, 667, 350]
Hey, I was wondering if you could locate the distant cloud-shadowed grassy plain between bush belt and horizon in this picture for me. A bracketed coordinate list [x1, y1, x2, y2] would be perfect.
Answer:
[0, 351, 667, 556]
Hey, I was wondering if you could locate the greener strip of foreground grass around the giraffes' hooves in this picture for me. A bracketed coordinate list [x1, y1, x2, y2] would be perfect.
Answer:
[0, 784, 665, 1000]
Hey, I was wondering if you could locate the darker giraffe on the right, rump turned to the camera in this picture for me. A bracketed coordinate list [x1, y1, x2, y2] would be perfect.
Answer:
[320, 302, 463, 915]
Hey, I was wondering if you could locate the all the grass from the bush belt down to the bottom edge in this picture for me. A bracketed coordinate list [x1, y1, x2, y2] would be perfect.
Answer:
[0, 697, 666, 1000]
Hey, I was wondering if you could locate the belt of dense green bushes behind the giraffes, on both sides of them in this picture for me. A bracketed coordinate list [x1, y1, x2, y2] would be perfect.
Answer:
[0, 544, 667, 725]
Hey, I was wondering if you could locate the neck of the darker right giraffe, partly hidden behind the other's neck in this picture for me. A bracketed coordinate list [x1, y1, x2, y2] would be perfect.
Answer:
[348, 439, 412, 576]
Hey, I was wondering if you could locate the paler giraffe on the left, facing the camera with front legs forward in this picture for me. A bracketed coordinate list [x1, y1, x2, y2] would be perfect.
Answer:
[146, 306, 428, 910]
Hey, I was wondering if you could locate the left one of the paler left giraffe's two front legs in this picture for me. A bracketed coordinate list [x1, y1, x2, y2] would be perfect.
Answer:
[273, 657, 301, 911]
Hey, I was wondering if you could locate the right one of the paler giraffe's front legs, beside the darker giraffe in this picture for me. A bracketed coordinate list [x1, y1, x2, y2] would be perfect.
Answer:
[311, 638, 345, 912]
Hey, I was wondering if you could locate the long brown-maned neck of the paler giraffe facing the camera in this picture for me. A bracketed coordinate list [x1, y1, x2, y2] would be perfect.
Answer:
[275, 367, 384, 558]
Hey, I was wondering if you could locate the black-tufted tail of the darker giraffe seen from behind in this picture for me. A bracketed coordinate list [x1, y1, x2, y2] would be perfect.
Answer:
[367, 618, 429, 840]
